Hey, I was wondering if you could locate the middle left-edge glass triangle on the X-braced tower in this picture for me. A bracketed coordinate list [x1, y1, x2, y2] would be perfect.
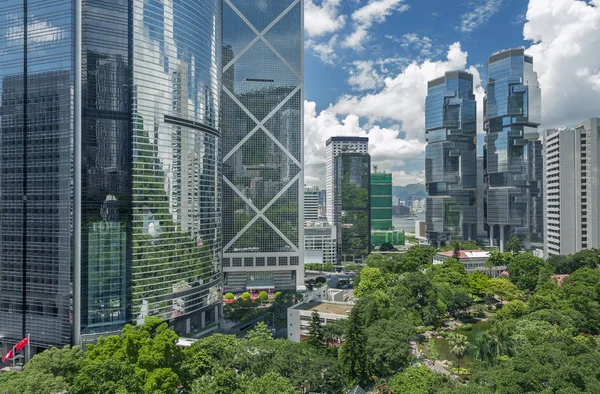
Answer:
[221, 92, 256, 156]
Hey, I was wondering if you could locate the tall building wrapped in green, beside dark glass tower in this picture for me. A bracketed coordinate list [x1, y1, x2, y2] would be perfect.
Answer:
[371, 172, 393, 230]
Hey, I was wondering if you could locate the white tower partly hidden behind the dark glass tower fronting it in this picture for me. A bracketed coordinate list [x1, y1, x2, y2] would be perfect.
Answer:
[325, 137, 369, 224]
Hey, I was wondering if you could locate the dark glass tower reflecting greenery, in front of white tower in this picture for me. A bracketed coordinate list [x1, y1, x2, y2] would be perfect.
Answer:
[333, 152, 371, 263]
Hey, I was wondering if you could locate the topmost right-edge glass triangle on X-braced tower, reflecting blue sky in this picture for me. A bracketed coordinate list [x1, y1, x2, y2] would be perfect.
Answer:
[264, 3, 302, 73]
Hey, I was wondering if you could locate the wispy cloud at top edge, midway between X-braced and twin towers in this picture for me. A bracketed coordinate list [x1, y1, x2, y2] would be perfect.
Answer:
[342, 0, 409, 50]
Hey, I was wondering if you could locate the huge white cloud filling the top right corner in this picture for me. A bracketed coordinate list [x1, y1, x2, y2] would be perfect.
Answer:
[523, 0, 600, 127]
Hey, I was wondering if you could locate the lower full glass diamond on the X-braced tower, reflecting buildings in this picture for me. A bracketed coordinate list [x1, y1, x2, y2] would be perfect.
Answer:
[223, 130, 300, 209]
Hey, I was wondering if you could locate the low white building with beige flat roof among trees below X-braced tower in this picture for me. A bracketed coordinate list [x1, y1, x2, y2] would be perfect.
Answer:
[287, 301, 353, 342]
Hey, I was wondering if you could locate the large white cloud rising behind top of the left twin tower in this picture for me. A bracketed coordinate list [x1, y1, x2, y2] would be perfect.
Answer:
[330, 42, 480, 141]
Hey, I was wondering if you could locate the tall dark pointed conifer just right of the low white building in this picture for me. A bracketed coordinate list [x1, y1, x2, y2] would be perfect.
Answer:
[339, 304, 368, 384]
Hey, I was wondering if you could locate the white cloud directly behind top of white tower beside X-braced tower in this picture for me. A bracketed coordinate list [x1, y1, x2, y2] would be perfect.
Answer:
[304, 101, 425, 186]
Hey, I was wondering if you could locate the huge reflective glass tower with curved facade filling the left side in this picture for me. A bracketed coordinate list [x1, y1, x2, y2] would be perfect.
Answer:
[0, 0, 222, 351]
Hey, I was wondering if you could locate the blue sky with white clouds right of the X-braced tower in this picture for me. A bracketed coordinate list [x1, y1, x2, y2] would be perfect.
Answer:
[304, 0, 600, 187]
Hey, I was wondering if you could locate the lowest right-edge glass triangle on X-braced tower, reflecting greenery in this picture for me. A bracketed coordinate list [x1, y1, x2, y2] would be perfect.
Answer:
[265, 180, 299, 246]
